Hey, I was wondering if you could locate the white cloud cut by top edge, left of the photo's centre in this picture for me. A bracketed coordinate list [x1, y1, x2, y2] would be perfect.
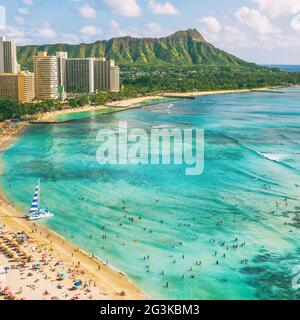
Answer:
[103, 0, 142, 17]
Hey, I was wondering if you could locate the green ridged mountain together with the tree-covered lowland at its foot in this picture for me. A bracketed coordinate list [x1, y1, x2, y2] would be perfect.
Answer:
[18, 29, 300, 91]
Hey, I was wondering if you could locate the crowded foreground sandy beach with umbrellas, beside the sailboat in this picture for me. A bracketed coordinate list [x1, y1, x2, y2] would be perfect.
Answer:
[0, 195, 147, 300]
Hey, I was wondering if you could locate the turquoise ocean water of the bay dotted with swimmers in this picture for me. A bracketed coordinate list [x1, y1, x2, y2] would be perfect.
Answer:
[0, 88, 300, 299]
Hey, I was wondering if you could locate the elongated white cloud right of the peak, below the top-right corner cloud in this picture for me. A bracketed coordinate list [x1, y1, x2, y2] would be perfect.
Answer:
[235, 7, 281, 34]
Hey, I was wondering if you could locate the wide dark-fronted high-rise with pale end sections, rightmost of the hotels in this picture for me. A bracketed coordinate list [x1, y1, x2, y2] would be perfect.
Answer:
[56, 52, 120, 93]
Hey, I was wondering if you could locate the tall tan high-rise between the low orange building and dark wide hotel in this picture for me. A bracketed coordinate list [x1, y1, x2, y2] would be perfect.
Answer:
[33, 52, 59, 100]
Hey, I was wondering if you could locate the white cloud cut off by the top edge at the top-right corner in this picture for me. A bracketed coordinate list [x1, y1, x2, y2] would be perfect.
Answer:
[252, 0, 300, 18]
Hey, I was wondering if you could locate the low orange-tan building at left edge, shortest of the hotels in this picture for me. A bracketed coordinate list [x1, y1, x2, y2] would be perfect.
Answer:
[0, 71, 35, 103]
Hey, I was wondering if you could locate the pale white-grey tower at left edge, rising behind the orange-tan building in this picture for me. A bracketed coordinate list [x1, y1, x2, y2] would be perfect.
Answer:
[0, 37, 20, 74]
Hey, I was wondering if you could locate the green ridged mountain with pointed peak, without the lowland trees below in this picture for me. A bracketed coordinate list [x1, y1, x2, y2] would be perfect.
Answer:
[18, 29, 255, 70]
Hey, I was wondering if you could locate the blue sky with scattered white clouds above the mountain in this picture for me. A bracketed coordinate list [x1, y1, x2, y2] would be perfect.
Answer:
[0, 0, 300, 64]
